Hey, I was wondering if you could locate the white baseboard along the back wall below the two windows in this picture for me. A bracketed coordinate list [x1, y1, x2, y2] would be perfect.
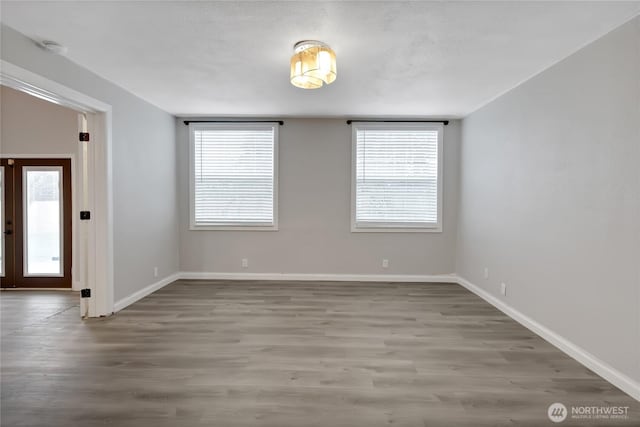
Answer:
[180, 271, 458, 283]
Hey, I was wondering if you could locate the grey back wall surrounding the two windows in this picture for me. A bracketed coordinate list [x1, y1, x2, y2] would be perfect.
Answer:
[176, 119, 460, 274]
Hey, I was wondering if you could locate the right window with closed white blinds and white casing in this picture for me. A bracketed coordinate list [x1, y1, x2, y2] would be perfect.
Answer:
[351, 123, 443, 232]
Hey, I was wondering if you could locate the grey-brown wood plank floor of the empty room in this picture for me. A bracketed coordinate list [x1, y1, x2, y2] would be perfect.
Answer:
[0, 281, 640, 427]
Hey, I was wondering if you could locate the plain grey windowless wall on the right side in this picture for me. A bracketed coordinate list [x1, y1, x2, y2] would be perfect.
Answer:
[456, 18, 640, 381]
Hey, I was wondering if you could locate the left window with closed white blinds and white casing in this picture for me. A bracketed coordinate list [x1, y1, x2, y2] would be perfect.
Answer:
[189, 123, 278, 230]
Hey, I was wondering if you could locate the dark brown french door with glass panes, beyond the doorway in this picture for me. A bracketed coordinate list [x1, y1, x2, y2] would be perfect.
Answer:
[0, 158, 72, 288]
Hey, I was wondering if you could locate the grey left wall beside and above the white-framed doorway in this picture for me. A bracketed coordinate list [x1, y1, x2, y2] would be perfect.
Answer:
[1, 25, 178, 301]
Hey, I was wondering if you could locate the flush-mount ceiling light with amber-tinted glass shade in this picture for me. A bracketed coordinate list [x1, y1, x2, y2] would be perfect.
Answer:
[291, 40, 337, 89]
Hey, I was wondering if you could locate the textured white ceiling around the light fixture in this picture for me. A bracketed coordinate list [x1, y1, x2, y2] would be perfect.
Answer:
[1, 1, 640, 117]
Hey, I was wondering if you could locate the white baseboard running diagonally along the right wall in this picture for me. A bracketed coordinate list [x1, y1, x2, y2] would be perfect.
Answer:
[457, 276, 640, 401]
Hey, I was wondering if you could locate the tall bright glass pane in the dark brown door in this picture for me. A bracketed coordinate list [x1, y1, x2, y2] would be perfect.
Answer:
[23, 166, 62, 276]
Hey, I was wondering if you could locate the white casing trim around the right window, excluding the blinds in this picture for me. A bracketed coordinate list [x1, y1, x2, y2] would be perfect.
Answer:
[351, 122, 444, 233]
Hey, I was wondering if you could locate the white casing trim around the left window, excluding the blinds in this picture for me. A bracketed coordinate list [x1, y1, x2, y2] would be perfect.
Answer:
[189, 122, 279, 231]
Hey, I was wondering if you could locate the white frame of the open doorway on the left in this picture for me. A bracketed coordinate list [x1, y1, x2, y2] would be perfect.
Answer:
[0, 60, 114, 317]
